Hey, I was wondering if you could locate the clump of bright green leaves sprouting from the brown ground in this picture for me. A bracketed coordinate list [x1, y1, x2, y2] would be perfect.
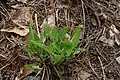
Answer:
[26, 21, 80, 64]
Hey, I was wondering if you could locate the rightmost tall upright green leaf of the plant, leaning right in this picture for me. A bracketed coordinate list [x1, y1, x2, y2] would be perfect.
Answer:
[70, 28, 80, 47]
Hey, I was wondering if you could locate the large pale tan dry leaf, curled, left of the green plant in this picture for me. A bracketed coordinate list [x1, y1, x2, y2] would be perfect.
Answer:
[1, 7, 31, 36]
